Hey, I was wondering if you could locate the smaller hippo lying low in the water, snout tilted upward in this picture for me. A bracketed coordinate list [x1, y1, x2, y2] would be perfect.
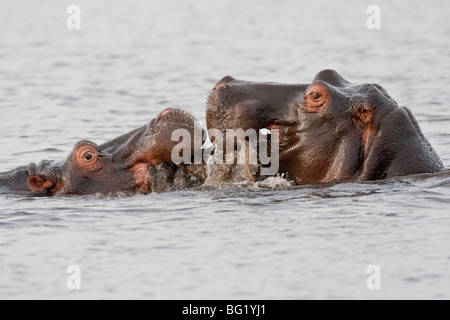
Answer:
[0, 108, 203, 195]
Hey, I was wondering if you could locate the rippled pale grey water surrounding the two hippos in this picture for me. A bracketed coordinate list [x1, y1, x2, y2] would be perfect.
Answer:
[0, 0, 450, 299]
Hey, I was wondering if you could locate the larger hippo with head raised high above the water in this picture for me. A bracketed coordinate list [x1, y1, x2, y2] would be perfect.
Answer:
[206, 70, 444, 184]
